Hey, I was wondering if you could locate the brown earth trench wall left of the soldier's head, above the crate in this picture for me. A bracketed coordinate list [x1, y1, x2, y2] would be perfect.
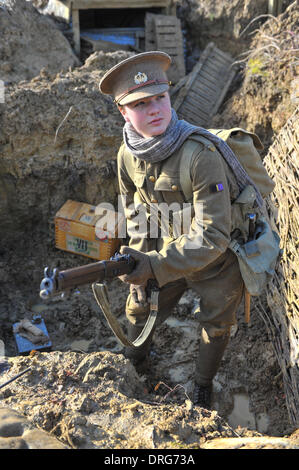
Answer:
[0, 51, 134, 243]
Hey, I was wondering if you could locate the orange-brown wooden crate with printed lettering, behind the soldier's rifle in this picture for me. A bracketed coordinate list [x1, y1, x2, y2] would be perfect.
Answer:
[55, 199, 121, 260]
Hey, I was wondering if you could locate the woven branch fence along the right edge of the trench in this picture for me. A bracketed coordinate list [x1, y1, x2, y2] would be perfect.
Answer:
[256, 107, 299, 426]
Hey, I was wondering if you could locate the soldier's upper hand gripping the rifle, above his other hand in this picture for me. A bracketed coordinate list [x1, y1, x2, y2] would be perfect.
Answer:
[119, 246, 155, 286]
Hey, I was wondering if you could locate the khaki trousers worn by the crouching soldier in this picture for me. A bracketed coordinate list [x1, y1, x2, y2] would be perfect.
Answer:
[126, 250, 244, 385]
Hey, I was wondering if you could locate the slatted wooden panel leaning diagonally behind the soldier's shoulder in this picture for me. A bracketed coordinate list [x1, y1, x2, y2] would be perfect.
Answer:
[171, 43, 236, 127]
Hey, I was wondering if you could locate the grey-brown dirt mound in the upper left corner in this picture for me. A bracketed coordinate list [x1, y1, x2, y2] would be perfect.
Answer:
[0, 0, 79, 82]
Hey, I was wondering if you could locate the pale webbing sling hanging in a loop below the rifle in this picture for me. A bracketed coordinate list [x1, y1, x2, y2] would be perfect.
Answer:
[92, 282, 159, 348]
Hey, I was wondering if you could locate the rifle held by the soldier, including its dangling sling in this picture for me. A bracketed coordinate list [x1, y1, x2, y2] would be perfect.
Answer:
[40, 253, 159, 348]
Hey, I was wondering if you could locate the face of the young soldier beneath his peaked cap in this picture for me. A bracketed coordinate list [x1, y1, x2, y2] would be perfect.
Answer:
[119, 92, 171, 138]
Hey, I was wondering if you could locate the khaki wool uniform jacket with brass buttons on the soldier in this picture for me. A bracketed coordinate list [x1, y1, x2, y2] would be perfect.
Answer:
[118, 139, 244, 287]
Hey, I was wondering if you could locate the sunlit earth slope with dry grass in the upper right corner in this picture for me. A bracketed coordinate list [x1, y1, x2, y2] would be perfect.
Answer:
[213, 1, 299, 150]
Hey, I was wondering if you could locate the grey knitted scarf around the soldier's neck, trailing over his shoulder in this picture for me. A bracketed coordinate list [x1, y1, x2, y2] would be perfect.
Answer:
[123, 109, 263, 207]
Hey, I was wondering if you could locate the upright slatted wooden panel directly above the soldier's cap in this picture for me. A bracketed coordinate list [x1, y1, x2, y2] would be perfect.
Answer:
[145, 13, 186, 83]
